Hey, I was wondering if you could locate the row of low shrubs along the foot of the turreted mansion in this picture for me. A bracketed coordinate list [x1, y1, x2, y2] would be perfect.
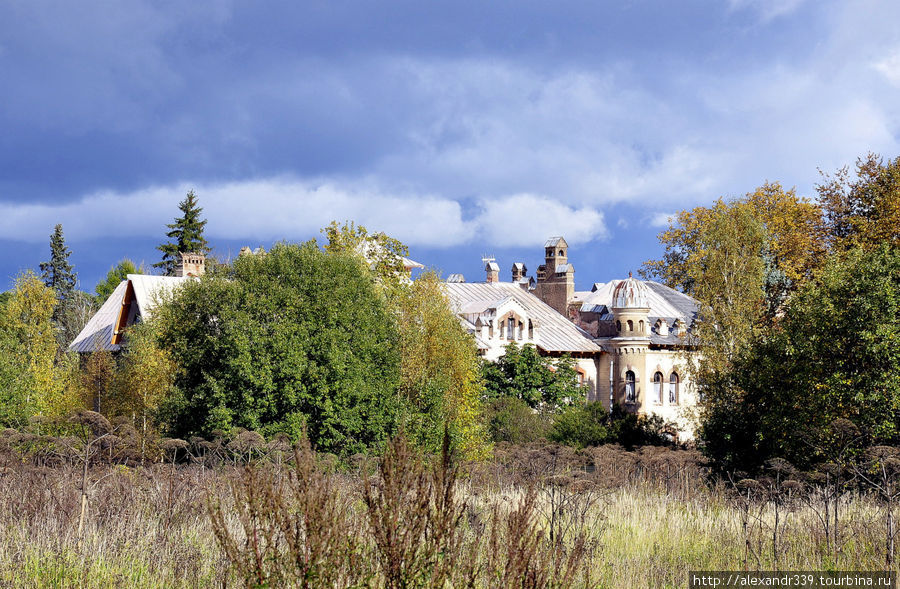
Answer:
[548, 401, 675, 449]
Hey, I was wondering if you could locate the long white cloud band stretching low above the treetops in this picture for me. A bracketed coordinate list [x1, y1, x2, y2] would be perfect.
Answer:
[0, 178, 606, 247]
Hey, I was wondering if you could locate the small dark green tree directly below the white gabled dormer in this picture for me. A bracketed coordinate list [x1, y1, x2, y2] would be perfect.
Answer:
[482, 342, 584, 412]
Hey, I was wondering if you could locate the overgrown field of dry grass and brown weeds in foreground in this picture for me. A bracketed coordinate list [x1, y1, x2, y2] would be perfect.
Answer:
[0, 440, 886, 588]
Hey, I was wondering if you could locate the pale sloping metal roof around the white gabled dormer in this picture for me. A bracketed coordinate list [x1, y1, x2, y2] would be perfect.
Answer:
[444, 282, 602, 353]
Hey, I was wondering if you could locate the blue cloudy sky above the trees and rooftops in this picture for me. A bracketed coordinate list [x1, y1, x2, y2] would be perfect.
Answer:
[0, 0, 900, 291]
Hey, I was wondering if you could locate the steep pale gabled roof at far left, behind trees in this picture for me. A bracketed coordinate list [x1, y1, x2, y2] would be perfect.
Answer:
[69, 274, 193, 353]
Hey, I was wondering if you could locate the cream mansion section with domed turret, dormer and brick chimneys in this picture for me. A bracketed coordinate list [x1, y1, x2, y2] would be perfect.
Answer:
[446, 237, 698, 439]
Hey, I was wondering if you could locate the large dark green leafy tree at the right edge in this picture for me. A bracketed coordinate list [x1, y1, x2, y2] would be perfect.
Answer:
[700, 245, 900, 471]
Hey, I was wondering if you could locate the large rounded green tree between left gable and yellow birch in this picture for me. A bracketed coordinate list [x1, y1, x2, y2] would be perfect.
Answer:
[155, 242, 406, 454]
